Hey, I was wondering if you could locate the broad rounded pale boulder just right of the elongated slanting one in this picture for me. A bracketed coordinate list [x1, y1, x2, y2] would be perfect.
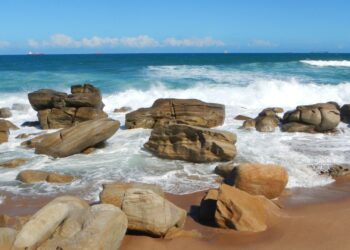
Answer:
[38, 204, 128, 250]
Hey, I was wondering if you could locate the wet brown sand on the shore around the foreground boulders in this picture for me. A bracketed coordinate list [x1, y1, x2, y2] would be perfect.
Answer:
[0, 179, 350, 250]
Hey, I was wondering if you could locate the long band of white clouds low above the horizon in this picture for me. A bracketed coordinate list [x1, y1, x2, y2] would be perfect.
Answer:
[27, 34, 225, 48]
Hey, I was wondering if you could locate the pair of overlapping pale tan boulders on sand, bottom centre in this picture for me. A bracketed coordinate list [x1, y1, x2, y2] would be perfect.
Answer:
[100, 183, 187, 237]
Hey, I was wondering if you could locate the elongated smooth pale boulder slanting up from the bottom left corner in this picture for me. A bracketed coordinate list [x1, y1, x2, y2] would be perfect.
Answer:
[13, 196, 89, 250]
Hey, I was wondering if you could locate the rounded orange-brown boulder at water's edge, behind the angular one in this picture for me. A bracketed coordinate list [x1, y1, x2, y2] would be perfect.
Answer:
[225, 163, 288, 199]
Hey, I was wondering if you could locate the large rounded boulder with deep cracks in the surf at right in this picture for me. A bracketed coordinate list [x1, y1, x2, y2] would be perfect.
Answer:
[282, 103, 340, 133]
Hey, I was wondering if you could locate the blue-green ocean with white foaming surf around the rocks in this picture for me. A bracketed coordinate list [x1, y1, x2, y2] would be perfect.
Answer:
[0, 53, 350, 200]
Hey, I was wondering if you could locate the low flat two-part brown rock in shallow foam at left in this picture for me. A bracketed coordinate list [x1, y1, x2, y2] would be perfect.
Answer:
[16, 170, 75, 184]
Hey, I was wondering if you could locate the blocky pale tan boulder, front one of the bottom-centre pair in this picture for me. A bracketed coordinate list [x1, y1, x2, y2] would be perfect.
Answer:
[122, 188, 187, 236]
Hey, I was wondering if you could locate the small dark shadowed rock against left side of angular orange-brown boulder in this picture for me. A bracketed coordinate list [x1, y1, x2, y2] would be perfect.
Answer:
[199, 189, 219, 225]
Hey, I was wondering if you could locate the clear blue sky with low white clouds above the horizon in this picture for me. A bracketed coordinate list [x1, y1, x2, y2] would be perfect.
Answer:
[0, 0, 350, 54]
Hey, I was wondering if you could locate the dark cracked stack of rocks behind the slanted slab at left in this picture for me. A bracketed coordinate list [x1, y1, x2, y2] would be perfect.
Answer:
[28, 84, 107, 129]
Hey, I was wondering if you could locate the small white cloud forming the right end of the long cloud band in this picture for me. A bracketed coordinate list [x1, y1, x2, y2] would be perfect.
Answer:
[164, 37, 225, 47]
